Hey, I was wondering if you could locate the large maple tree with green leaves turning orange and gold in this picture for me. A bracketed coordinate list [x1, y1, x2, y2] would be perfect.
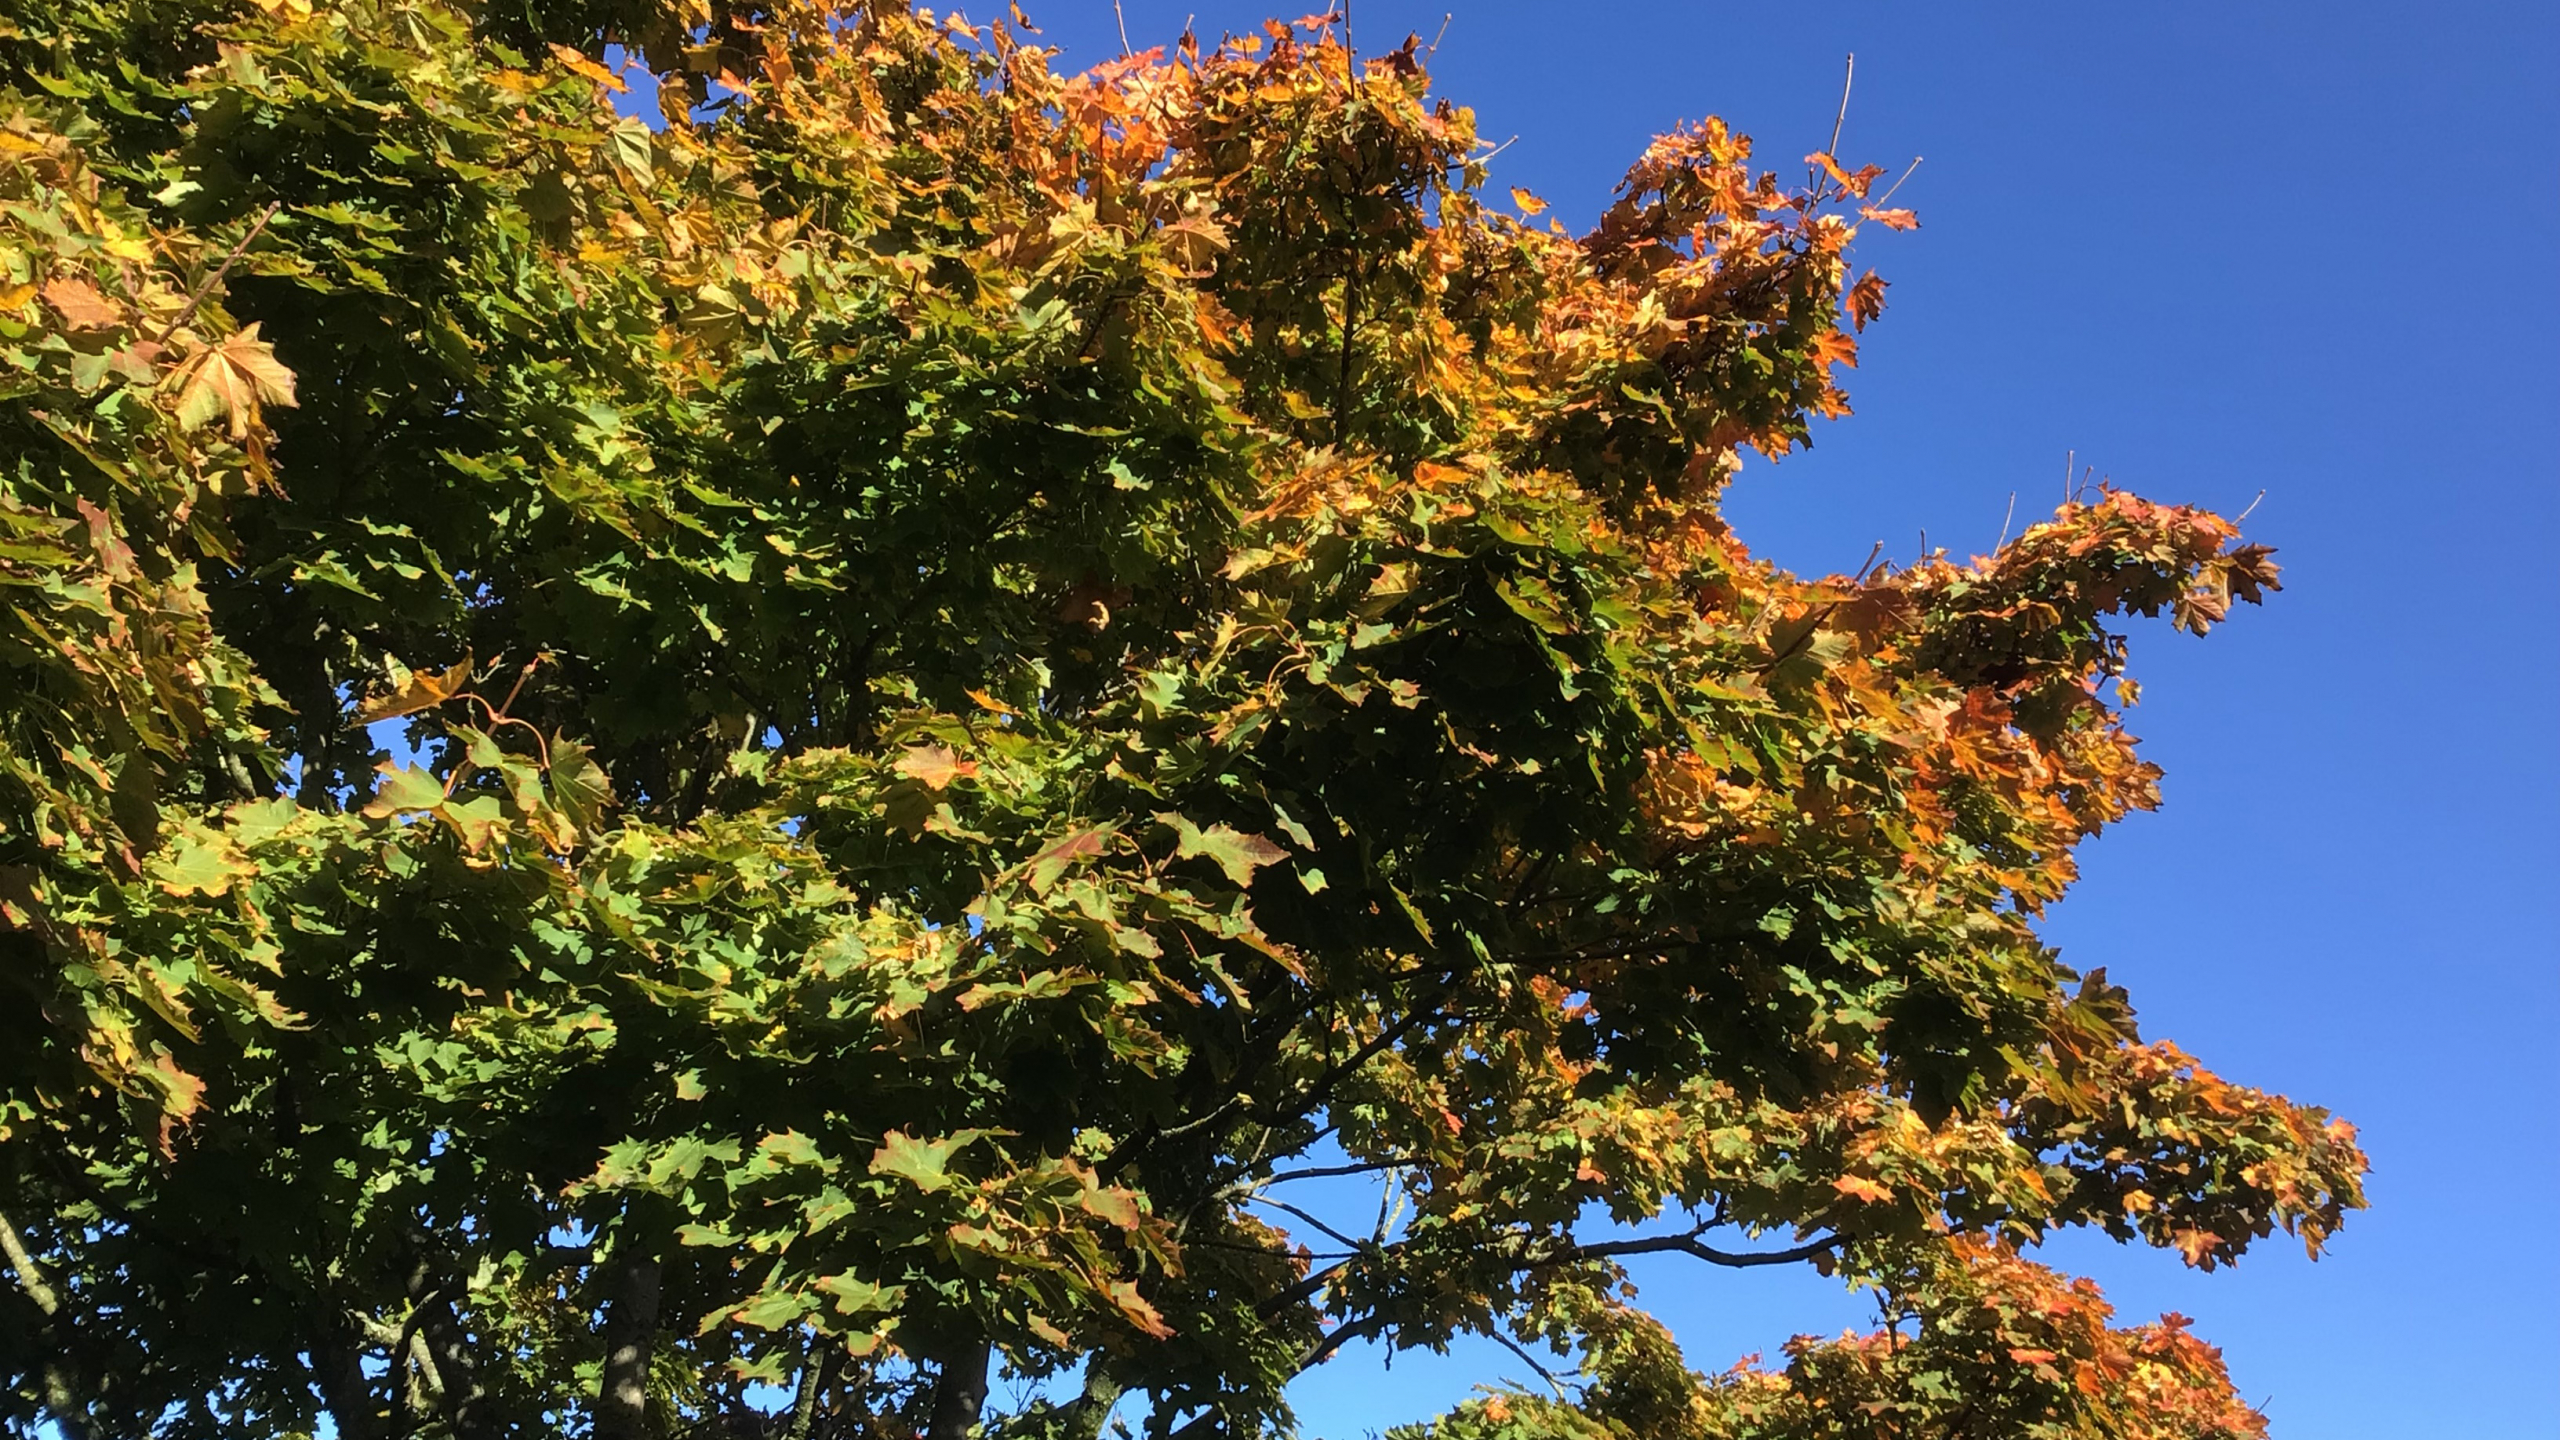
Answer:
[0, 0, 2365, 1440]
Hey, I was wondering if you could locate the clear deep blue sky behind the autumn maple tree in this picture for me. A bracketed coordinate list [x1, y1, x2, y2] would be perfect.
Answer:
[970, 0, 2560, 1440]
